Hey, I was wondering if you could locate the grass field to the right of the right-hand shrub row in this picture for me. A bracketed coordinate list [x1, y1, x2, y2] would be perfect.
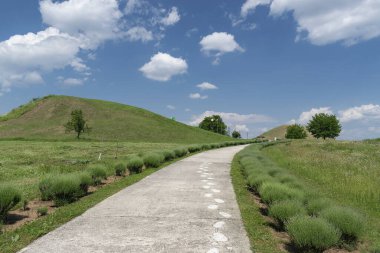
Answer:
[262, 140, 380, 252]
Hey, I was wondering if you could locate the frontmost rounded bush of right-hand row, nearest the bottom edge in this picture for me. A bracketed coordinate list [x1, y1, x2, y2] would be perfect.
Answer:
[286, 216, 341, 251]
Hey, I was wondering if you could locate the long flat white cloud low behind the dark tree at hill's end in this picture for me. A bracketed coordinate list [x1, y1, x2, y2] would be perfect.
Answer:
[190, 111, 274, 126]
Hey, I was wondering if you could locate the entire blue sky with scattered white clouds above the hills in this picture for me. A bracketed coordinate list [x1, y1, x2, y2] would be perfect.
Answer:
[0, 0, 380, 140]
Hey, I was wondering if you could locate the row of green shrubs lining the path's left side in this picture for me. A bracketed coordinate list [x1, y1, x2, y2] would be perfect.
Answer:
[0, 140, 256, 219]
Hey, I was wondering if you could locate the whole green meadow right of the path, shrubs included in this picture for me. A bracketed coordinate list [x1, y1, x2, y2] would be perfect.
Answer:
[232, 140, 380, 252]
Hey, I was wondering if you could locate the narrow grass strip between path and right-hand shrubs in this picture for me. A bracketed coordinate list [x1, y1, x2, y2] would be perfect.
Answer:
[231, 151, 282, 253]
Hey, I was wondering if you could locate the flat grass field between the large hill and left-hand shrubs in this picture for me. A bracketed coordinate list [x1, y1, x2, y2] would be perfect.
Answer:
[0, 141, 181, 202]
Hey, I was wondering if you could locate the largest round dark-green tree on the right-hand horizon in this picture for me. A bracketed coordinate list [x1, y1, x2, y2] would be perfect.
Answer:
[306, 113, 342, 140]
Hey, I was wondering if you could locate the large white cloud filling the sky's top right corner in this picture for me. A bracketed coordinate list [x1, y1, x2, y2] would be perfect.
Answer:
[241, 0, 380, 46]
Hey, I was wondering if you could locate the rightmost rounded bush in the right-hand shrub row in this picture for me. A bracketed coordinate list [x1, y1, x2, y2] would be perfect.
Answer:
[320, 206, 365, 241]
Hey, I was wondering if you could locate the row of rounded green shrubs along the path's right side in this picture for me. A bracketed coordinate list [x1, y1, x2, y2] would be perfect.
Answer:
[238, 147, 365, 251]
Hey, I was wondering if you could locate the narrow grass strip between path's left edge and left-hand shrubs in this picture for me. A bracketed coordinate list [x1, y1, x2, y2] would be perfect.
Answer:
[0, 153, 196, 253]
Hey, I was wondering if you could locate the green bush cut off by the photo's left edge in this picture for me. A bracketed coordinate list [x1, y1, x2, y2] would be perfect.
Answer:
[0, 186, 21, 221]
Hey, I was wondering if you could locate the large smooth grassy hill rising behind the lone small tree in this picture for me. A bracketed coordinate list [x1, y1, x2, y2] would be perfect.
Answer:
[0, 96, 232, 143]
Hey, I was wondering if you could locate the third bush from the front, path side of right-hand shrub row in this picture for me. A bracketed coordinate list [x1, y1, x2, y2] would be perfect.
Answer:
[259, 182, 304, 204]
